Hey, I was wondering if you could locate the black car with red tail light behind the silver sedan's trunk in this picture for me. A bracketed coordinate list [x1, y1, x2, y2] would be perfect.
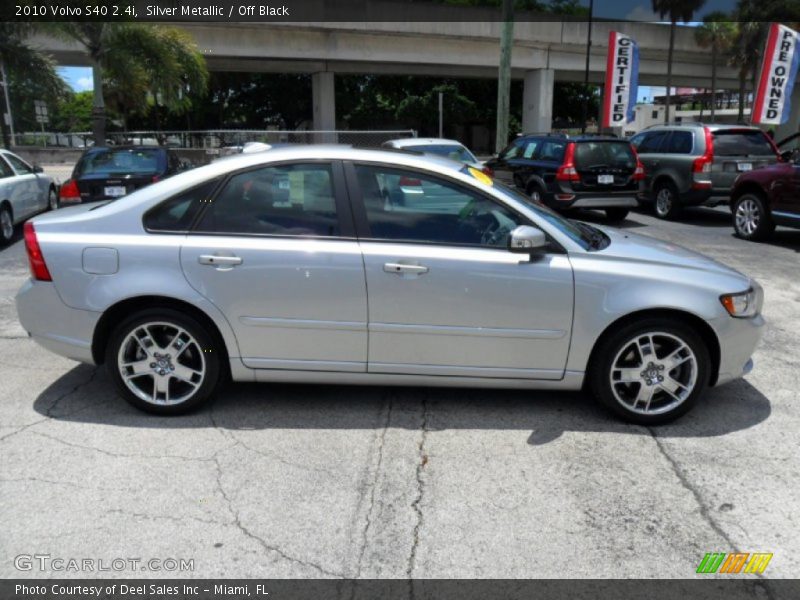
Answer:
[59, 146, 184, 204]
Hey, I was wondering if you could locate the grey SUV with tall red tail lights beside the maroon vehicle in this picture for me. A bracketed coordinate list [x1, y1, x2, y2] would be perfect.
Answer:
[631, 123, 778, 219]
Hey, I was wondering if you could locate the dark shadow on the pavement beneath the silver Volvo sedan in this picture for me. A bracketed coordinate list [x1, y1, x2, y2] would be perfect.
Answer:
[34, 365, 771, 446]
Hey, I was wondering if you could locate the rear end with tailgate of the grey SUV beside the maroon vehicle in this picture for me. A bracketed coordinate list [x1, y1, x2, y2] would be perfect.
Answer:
[711, 128, 778, 195]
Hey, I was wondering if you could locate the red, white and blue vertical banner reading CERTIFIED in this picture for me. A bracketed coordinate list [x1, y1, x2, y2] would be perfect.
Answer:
[600, 31, 639, 128]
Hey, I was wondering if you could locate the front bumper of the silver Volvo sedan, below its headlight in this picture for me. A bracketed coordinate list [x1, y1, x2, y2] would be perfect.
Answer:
[711, 314, 765, 385]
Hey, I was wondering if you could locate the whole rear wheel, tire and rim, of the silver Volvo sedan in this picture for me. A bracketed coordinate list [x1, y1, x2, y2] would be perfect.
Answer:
[105, 308, 224, 415]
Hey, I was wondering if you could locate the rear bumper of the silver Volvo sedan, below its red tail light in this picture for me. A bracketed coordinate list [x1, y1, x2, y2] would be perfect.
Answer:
[16, 279, 100, 364]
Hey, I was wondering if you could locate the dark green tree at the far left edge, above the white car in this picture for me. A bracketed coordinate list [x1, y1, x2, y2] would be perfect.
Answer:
[0, 22, 64, 148]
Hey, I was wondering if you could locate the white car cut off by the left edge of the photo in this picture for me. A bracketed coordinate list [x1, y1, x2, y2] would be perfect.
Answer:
[0, 150, 58, 245]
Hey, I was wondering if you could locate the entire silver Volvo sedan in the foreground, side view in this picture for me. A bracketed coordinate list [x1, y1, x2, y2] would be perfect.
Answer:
[17, 146, 764, 423]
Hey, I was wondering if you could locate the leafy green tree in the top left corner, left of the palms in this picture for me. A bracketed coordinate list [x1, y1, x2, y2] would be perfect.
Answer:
[0, 22, 67, 148]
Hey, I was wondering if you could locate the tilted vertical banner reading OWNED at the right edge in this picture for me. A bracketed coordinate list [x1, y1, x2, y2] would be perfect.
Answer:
[750, 23, 800, 125]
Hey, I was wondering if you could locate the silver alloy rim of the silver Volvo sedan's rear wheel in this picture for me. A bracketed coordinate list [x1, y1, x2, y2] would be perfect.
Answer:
[117, 321, 206, 406]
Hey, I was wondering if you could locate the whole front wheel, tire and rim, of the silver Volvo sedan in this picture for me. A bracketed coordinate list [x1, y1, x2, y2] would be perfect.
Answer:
[589, 317, 711, 425]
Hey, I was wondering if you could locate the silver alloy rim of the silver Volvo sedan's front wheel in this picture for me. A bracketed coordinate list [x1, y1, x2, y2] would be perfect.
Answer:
[609, 331, 698, 415]
